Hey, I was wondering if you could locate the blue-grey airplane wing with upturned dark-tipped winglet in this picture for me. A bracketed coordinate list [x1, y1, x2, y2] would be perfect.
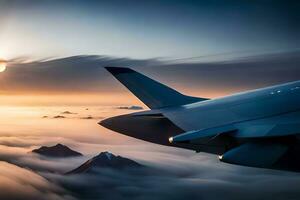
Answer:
[99, 67, 300, 171]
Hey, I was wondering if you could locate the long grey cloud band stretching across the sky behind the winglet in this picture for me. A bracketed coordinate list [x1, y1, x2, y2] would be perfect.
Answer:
[0, 51, 300, 94]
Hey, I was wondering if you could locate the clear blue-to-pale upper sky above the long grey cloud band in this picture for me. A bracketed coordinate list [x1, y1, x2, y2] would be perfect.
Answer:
[0, 0, 300, 60]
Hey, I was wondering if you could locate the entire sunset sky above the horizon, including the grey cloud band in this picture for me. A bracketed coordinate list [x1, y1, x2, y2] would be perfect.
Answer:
[0, 0, 300, 104]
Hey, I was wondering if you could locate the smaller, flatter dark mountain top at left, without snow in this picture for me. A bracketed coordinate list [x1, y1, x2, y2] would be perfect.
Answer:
[32, 144, 82, 158]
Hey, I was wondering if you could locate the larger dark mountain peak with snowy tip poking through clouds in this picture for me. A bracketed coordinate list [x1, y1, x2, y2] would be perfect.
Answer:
[66, 152, 144, 174]
